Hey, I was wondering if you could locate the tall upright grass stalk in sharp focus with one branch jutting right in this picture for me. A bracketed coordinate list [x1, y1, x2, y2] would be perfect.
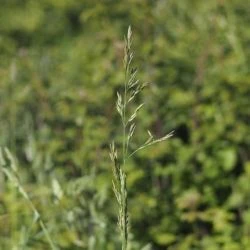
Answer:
[110, 26, 173, 250]
